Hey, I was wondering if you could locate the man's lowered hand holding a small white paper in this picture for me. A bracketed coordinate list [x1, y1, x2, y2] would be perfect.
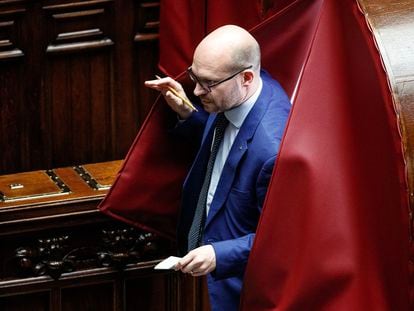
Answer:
[175, 245, 216, 276]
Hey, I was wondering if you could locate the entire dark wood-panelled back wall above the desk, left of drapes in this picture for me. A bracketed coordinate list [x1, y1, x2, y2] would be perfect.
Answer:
[0, 0, 159, 174]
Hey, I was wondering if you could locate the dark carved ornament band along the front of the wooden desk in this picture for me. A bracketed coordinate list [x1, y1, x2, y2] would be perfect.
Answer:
[14, 226, 165, 280]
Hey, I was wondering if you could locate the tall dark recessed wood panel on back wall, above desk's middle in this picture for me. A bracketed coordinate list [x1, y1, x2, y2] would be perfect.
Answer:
[42, 52, 113, 165]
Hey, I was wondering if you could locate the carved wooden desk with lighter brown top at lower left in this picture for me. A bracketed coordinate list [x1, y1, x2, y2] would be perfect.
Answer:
[0, 161, 206, 311]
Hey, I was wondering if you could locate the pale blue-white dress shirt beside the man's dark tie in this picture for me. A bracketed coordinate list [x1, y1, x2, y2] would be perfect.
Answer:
[206, 79, 263, 214]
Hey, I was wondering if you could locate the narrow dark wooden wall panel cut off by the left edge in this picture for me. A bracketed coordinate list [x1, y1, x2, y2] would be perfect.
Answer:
[0, 1, 27, 172]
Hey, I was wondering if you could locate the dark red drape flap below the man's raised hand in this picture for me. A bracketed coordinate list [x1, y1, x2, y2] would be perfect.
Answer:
[98, 98, 194, 240]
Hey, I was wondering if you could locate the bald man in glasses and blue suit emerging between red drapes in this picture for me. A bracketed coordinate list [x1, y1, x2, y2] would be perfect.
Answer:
[145, 25, 291, 311]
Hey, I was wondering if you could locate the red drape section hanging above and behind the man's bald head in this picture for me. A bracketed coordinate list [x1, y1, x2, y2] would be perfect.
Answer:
[160, 0, 294, 77]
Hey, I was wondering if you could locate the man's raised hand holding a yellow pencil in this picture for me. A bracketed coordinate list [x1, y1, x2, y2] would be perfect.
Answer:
[145, 77, 193, 120]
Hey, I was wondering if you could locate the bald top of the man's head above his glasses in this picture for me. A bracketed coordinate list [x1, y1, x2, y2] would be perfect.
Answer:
[194, 25, 260, 72]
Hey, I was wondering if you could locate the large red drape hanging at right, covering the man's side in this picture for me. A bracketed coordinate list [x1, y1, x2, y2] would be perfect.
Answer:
[242, 0, 409, 311]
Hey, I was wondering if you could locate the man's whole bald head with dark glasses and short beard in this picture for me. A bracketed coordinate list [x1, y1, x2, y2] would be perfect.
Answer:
[189, 25, 260, 112]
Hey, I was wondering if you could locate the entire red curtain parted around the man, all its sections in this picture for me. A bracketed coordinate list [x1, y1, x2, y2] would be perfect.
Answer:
[100, 0, 409, 311]
